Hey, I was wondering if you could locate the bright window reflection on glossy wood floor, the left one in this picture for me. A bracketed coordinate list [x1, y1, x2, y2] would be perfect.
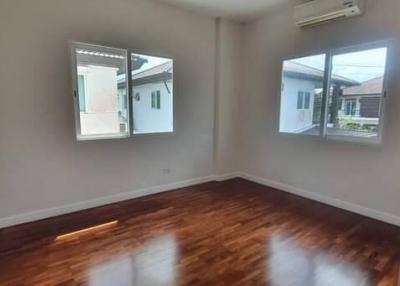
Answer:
[89, 235, 178, 286]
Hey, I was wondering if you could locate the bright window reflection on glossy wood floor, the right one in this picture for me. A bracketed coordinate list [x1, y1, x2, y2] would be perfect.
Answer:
[267, 236, 371, 286]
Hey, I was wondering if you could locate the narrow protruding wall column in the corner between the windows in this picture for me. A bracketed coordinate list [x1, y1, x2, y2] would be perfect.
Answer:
[214, 19, 243, 174]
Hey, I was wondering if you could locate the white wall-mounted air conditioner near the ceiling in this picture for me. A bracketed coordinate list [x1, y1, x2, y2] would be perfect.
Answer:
[294, 0, 364, 27]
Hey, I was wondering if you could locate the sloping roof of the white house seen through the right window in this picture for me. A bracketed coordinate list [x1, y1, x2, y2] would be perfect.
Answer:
[284, 61, 359, 86]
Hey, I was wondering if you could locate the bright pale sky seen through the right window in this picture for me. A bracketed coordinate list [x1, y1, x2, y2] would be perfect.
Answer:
[292, 48, 387, 83]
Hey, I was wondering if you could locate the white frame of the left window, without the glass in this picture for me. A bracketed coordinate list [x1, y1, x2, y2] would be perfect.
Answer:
[68, 41, 176, 141]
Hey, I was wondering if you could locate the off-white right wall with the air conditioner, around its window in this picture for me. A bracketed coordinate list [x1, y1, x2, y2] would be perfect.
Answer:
[240, 0, 400, 216]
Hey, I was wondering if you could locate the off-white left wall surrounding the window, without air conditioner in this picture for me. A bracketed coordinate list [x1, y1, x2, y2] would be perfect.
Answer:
[0, 0, 219, 221]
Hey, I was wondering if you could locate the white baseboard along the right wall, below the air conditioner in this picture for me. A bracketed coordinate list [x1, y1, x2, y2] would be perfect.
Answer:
[239, 172, 400, 226]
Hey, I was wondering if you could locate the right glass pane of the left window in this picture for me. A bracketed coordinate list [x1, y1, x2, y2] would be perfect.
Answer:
[131, 54, 174, 134]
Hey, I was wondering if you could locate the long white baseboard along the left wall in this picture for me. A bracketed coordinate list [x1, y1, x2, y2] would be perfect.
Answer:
[0, 175, 231, 229]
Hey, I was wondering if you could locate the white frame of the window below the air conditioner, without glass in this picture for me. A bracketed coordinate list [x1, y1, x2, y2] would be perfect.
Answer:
[277, 39, 393, 145]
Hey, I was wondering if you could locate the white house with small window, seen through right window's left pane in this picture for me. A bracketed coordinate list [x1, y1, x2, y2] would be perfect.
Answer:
[280, 61, 357, 133]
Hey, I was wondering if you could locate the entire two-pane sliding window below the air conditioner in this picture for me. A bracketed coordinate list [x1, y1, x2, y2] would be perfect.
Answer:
[279, 42, 388, 143]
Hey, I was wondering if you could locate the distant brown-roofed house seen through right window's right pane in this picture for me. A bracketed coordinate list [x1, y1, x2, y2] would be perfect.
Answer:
[339, 77, 383, 125]
